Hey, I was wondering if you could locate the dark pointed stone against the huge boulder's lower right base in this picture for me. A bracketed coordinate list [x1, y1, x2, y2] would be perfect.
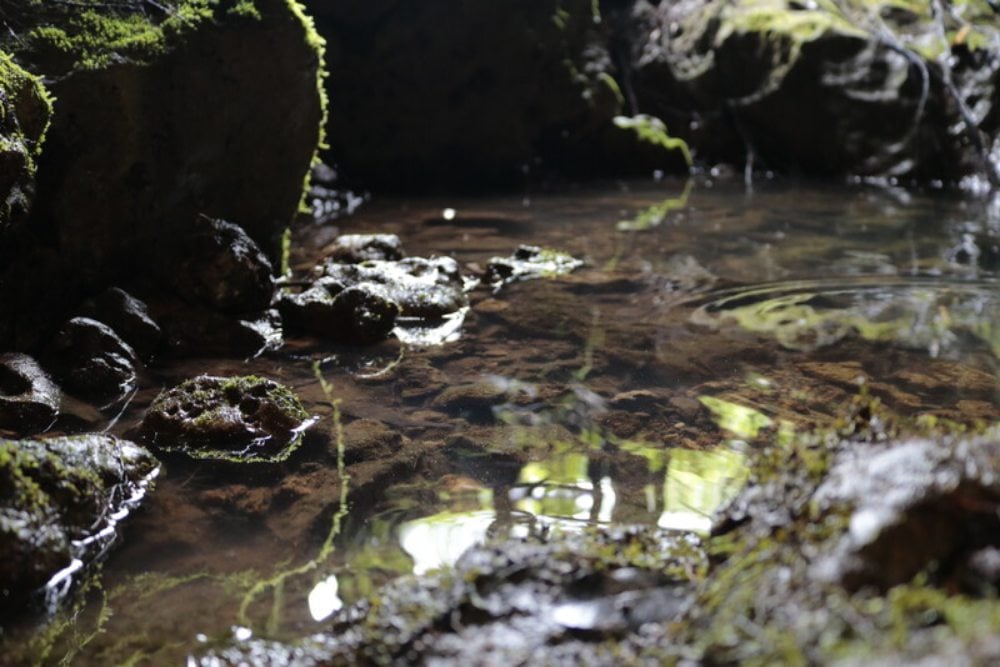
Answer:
[165, 218, 274, 314]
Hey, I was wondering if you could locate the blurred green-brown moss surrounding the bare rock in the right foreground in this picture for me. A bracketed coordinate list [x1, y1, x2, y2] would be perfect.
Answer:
[646, 393, 1000, 665]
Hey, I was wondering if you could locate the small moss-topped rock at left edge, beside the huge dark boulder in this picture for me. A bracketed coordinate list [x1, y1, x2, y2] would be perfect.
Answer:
[0, 51, 51, 247]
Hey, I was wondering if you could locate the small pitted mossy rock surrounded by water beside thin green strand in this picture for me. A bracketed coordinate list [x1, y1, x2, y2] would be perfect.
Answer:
[137, 375, 314, 463]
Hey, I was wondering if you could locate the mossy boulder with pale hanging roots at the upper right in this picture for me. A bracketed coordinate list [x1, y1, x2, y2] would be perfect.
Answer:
[623, 0, 1000, 185]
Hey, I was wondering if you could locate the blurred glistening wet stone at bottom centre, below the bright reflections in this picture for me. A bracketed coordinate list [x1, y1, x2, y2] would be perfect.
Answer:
[278, 527, 704, 665]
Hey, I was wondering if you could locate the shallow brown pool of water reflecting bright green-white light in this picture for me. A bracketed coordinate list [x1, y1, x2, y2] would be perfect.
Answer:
[0, 181, 1000, 665]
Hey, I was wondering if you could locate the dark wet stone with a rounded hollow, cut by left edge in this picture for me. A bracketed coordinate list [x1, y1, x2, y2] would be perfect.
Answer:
[0, 353, 61, 435]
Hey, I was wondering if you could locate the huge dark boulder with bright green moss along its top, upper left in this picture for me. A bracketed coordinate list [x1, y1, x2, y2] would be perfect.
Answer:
[0, 0, 324, 344]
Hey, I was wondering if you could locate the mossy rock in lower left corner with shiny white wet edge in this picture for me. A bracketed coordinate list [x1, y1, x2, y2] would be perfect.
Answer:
[0, 435, 157, 617]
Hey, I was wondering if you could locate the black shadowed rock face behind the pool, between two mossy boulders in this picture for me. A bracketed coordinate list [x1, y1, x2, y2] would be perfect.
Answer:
[306, 0, 625, 189]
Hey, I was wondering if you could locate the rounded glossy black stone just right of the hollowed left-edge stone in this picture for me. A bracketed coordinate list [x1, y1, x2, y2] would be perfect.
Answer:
[45, 317, 139, 403]
